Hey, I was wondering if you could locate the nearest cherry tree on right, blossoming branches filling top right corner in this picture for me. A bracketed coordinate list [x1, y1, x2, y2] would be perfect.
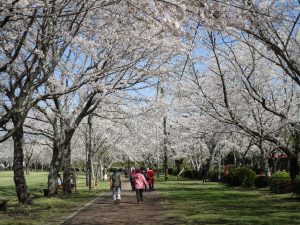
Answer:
[127, 0, 300, 179]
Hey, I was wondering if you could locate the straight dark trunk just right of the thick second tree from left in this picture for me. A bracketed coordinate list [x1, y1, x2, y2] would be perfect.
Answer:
[63, 143, 72, 194]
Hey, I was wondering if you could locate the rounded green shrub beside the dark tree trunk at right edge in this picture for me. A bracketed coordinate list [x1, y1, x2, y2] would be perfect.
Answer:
[270, 171, 292, 194]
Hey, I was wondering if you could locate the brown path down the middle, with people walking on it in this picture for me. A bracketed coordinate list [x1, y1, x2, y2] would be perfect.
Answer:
[62, 180, 178, 225]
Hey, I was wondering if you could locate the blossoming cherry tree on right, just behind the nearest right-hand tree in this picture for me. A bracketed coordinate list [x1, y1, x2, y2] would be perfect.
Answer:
[178, 29, 299, 178]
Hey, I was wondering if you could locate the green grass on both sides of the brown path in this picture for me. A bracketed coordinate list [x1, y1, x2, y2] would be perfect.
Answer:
[0, 171, 300, 225]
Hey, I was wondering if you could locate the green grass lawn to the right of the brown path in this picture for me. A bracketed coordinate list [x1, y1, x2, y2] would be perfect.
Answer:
[156, 177, 300, 225]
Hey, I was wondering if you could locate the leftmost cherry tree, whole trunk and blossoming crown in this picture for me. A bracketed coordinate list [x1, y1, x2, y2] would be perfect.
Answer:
[0, 0, 123, 203]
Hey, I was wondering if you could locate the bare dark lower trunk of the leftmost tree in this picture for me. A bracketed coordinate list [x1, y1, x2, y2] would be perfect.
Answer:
[13, 122, 30, 204]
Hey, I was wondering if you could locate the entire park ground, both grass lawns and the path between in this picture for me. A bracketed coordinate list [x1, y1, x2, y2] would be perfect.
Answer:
[0, 171, 300, 225]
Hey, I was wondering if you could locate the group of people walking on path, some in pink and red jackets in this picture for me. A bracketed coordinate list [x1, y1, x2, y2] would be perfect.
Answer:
[110, 167, 154, 204]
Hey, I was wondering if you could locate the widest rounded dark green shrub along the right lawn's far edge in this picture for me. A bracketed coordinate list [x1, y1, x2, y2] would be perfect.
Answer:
[224, 167, 256, 186]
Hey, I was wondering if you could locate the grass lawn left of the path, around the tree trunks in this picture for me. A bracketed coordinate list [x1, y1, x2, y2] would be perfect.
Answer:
[0, 171, 109, 225]
